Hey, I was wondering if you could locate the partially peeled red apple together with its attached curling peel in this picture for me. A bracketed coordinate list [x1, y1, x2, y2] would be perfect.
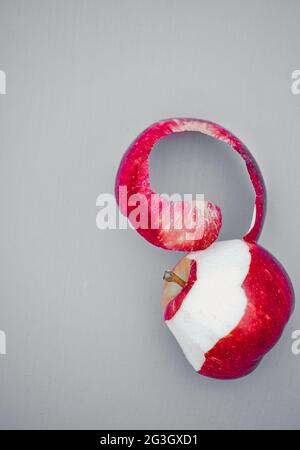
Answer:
[116, 119, 294, 379]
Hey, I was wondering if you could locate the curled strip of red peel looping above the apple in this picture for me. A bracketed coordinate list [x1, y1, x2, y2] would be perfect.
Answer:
[115, 119, 265, 252]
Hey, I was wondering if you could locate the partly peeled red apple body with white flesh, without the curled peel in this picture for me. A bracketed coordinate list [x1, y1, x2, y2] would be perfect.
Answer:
[163, 239, 294, 379]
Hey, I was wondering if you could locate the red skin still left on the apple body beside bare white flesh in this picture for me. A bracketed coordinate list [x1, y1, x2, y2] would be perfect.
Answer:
[164, 243, 294, 380]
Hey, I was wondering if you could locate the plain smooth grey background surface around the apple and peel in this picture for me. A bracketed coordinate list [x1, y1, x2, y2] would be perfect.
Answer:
[0, 0, 300, 429]
